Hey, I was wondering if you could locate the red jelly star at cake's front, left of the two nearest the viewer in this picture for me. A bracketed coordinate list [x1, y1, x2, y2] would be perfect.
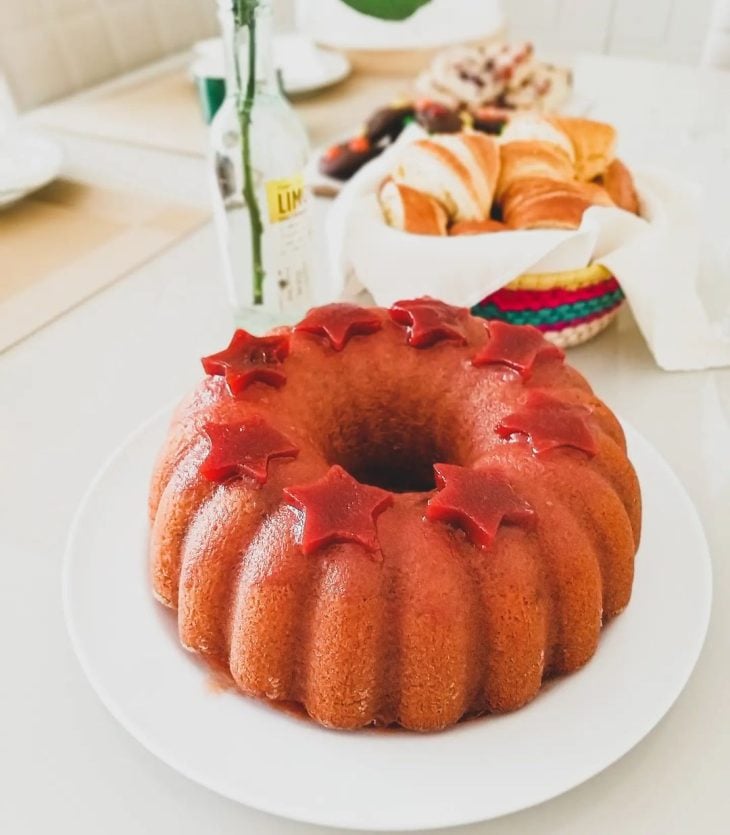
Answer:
[284, 466, 393, 555]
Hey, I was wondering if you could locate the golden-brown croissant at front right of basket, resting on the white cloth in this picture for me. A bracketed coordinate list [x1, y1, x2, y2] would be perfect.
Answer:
[502, 177, 614, 229]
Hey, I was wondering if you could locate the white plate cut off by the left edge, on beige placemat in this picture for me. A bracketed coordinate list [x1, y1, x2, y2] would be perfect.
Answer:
[0, 130, 63, 206]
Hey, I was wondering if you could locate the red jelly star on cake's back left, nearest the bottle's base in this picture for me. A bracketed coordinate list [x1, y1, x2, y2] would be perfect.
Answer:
[201, 330, 289, 395]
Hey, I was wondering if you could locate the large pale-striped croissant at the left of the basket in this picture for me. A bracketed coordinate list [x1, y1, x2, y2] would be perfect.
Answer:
[393, 131, 500, 221]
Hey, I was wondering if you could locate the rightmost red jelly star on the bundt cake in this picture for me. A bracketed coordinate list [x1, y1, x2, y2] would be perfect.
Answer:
[497, 391, 598, 457]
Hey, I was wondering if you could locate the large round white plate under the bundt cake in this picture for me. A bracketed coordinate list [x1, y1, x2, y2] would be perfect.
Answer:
[64, 411, 712, 830]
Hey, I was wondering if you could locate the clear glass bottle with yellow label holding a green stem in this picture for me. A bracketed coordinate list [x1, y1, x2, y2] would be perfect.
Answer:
[211, 0, 314, 333]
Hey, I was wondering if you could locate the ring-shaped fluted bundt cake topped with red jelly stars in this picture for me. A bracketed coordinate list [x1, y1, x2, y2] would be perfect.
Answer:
[149, 298, 641, 731]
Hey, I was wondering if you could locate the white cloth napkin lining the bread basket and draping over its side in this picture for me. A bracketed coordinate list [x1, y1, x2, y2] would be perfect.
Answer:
[328, 128, 730, 371]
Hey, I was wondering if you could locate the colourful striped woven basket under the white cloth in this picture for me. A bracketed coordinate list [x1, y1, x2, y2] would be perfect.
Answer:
[472, 264, 625, 348]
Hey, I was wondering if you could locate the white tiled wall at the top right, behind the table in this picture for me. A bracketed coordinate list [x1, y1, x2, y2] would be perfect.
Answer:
[504, 0, 712, 63]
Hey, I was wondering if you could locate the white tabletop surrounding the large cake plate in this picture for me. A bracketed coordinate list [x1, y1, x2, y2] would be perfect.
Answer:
[0, 58, 730, 835]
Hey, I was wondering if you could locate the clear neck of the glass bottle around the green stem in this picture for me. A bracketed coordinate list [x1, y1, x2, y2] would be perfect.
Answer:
[218, 0, 281, 95]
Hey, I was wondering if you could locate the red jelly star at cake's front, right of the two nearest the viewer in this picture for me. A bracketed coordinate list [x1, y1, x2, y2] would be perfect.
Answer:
[426, 464, 535, 547]
